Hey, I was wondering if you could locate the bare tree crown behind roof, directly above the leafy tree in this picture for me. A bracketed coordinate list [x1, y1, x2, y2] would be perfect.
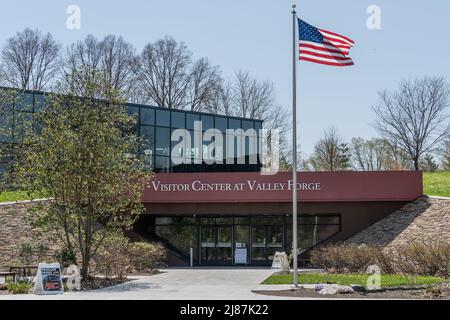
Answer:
[63, 35, 139, 100]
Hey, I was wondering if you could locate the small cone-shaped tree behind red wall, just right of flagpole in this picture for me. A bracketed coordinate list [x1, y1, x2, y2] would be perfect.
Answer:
[310, 127, 350, 171]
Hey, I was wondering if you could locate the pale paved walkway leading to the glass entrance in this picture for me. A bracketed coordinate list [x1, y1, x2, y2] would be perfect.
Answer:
[0, 268, 296, 300]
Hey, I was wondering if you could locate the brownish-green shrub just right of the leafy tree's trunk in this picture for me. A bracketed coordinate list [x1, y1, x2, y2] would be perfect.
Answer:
[92, 233, 131, 279]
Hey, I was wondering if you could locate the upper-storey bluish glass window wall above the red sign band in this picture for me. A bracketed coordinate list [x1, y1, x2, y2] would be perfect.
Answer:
[0, 89, 262, 172]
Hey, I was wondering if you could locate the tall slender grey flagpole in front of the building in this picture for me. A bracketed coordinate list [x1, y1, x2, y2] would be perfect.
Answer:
[292, 4, 298, 288]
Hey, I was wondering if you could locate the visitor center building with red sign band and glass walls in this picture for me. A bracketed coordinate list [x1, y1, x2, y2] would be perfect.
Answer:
[0, 91, 422, 266]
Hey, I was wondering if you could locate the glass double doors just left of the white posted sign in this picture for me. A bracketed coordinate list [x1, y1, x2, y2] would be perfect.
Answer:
[200, 226, 233, 265]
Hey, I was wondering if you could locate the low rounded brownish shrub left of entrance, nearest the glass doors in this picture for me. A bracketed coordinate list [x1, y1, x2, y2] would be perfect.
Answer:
[129, 242, 166, 272]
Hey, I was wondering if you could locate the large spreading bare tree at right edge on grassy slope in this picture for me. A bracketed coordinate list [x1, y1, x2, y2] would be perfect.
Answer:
[373, 78, 450, 170]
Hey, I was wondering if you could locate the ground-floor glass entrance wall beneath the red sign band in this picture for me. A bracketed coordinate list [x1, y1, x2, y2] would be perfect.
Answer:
[154, 214, 341, 265]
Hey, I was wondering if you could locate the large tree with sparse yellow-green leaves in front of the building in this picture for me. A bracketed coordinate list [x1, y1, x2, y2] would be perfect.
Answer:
[18, 83, 150, 277]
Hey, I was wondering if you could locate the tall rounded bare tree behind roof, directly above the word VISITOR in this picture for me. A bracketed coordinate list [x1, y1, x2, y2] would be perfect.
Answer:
[140, 37, 192, 109]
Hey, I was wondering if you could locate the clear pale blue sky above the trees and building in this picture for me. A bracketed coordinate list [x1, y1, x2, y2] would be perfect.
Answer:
[0, 0, 450, 153]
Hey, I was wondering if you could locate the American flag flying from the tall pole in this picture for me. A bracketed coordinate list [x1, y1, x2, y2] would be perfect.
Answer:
[298, 19, 355, 67]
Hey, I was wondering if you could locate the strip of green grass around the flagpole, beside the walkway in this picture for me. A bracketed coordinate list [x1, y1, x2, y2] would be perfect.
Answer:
[263, 273, 446, 287]
